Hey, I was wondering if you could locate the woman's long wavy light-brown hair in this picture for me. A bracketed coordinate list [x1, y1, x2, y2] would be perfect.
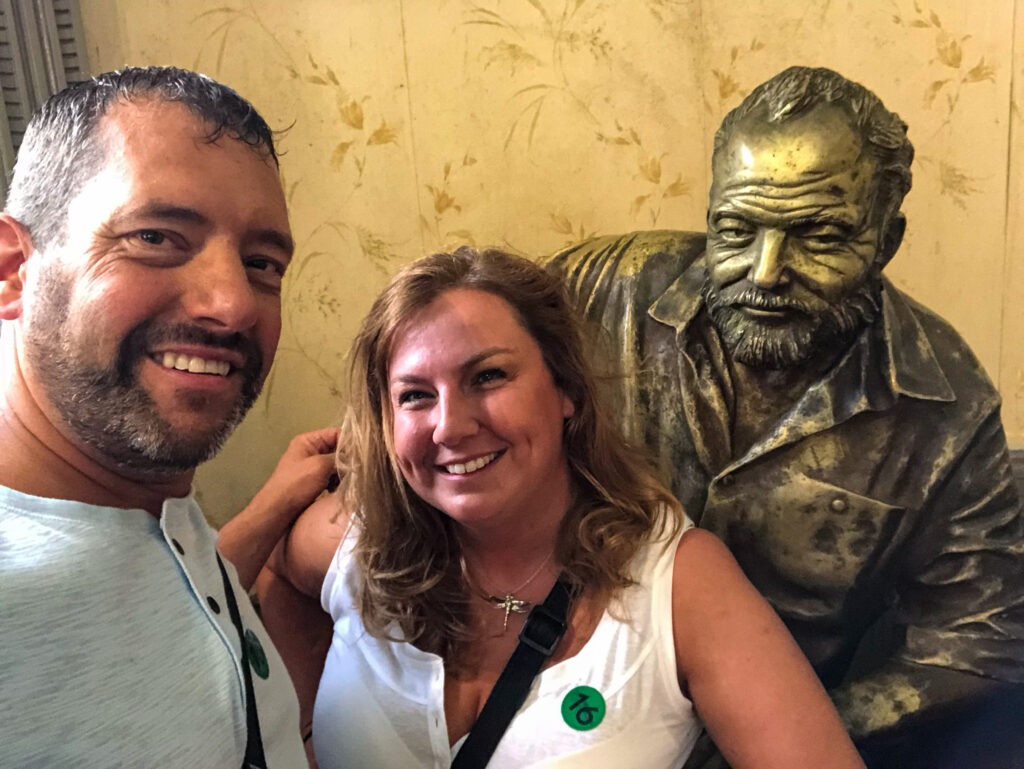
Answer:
[338, 247, 681, 670]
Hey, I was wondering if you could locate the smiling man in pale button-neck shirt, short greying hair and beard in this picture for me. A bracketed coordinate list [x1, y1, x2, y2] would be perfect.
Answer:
[0, 68, 331, 769]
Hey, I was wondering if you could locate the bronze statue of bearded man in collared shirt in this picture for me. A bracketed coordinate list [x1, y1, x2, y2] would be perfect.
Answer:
[551, 68, 1024, 766]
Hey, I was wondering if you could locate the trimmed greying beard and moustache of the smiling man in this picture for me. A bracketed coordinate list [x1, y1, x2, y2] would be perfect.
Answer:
[25, 266, 262, 477]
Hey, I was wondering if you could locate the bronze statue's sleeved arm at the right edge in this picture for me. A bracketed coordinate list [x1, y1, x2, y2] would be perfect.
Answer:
[831, 407, 1024, 765]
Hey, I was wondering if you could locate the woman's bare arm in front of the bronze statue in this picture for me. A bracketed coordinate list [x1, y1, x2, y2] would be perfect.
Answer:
[672, 529, 864, 769]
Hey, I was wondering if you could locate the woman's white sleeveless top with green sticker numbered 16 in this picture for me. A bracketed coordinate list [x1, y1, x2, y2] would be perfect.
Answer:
[313, 519, 701, 769]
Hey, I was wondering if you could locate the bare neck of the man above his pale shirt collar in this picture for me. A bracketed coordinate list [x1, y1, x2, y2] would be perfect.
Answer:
[0, 372, 194, 518]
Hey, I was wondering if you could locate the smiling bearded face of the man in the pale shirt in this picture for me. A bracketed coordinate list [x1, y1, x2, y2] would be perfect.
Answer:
[23, 101, 292, 475]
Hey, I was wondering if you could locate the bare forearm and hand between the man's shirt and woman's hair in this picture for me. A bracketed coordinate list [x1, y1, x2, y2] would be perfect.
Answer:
[217, 427, 338, 590]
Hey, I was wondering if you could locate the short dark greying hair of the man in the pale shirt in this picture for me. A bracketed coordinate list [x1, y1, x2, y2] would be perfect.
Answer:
[7, 67, 278, 248]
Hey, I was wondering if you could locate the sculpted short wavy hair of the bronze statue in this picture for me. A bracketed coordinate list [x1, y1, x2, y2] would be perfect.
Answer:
[714, 67, 913, 224]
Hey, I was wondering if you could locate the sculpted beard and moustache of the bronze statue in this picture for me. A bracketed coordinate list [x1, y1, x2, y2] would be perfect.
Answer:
[701, 276, 882, 370]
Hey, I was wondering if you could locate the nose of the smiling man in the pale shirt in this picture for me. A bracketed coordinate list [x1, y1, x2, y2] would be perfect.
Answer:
[182, 244, 257, 332]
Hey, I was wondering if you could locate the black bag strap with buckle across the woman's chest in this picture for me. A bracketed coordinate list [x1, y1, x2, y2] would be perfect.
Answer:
[452, 576, 570, 769]
